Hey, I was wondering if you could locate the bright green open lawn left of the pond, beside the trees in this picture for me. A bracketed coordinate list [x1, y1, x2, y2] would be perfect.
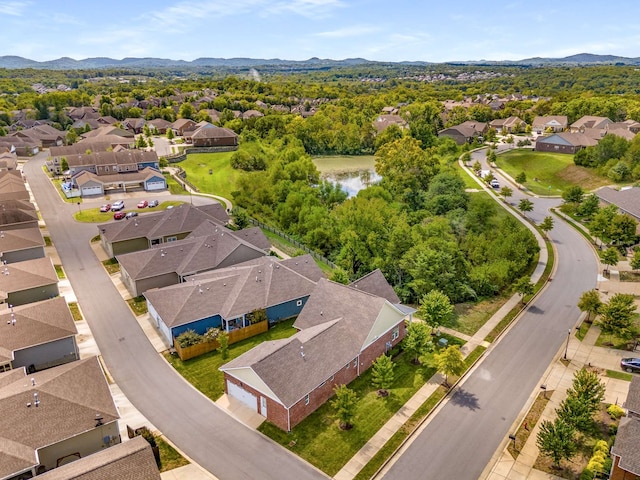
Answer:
[175, 152, 241, 199]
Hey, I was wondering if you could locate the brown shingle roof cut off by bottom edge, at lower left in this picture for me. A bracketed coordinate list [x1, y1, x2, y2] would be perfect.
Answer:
[38, 435, 161, 480]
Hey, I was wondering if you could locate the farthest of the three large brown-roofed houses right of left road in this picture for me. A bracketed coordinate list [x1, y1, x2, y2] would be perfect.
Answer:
[98, 203, 229, 257]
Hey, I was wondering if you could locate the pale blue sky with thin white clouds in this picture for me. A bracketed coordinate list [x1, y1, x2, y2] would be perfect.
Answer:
[0, 0, 640, 62]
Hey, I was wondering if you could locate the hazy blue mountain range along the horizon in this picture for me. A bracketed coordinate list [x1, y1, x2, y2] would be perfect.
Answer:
[0, 53, 640, 70]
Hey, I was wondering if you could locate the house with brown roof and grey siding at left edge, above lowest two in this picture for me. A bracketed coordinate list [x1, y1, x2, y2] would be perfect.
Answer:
[0, 297, 80, 373]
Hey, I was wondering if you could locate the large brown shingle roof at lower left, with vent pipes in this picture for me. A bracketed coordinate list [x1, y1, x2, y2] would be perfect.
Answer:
[0, 357, 118, 478]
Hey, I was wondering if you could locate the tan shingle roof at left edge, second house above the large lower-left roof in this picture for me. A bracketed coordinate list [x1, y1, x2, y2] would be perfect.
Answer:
[0, 257, 58, 293]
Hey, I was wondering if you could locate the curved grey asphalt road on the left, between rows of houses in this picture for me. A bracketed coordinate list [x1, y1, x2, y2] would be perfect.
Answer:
[24, 154, 327, 480]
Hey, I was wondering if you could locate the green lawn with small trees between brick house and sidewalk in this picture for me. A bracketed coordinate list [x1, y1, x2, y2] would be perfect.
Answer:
[258, 337, 462, 476]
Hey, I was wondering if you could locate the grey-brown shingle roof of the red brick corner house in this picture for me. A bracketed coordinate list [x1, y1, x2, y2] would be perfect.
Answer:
[220, 279, 404, 407]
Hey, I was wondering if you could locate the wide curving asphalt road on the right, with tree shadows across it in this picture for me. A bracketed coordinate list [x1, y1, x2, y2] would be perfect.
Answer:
[382, 151, 598, 480]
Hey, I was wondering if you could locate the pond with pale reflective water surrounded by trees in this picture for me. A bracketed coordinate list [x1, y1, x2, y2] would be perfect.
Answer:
[313, 155, 382, 197]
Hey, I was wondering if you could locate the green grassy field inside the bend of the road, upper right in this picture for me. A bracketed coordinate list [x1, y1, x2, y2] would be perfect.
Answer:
[496, 149, 611, 195]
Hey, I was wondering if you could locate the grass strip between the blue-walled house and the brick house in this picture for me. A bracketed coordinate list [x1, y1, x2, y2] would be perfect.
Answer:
[165, 319, 297, 401]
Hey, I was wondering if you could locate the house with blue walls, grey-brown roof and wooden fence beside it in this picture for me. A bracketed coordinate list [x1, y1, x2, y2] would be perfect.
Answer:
[144, 255, 324, 345]
